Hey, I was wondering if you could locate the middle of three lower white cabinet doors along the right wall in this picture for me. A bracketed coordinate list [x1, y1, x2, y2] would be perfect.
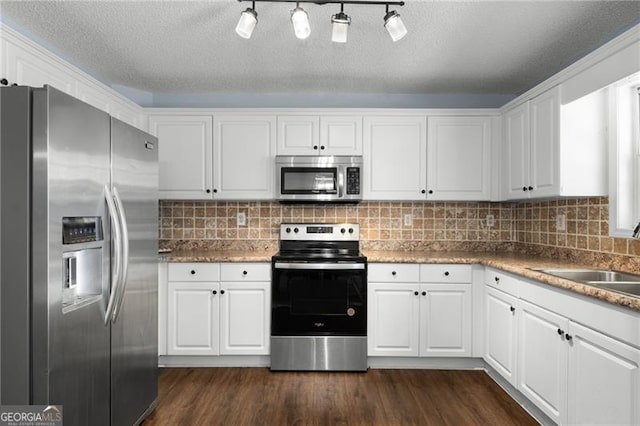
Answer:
[518, 301, 569, 424]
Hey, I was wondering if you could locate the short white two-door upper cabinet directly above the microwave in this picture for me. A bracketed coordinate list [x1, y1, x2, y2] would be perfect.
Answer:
[277, 115, 362, 155]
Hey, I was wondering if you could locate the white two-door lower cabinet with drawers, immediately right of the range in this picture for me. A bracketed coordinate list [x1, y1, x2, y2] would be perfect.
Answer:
[368, 264, 472, 357]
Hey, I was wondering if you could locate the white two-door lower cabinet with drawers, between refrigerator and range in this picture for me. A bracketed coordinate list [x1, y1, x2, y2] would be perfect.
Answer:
[167, 263, 271, 355]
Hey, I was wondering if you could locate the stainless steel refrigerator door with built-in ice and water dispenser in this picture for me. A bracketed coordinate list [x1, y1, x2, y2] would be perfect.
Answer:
[31, 87, 110, 425]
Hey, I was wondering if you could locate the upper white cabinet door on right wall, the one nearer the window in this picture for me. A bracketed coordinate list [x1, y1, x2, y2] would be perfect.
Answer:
[529, 86, 560, 197]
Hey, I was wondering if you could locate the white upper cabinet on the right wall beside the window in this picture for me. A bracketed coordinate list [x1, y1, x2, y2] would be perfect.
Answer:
[504, 86, 608, 199]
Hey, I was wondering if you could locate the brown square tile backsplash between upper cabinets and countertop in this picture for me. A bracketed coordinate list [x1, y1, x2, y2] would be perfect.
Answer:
[160, 197, 640, 256]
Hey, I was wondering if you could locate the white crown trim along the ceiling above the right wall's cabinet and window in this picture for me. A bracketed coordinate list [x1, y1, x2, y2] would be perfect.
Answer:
[500, 24, 640, 112]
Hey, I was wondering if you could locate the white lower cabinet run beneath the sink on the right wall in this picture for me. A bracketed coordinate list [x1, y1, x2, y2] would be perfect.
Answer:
[485, 271, 640, 425]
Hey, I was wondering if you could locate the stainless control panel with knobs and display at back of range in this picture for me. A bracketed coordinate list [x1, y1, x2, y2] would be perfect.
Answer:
[280, 223, 360, 241]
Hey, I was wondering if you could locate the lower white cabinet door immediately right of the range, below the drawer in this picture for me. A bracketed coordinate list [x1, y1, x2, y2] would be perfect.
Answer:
[367, 283, 420, 356]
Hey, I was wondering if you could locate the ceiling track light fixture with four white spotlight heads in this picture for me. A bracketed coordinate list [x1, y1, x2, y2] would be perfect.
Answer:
[236, 0, 407, 43]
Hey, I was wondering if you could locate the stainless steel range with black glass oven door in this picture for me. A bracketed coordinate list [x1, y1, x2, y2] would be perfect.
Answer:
[271, 223, 367, 371]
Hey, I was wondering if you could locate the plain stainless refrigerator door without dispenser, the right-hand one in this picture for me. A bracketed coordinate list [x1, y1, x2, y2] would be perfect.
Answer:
[111, 118, 158, 425]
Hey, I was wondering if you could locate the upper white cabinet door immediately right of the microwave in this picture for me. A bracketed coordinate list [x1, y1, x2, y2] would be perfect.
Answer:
[363, 117, 427, 200]
